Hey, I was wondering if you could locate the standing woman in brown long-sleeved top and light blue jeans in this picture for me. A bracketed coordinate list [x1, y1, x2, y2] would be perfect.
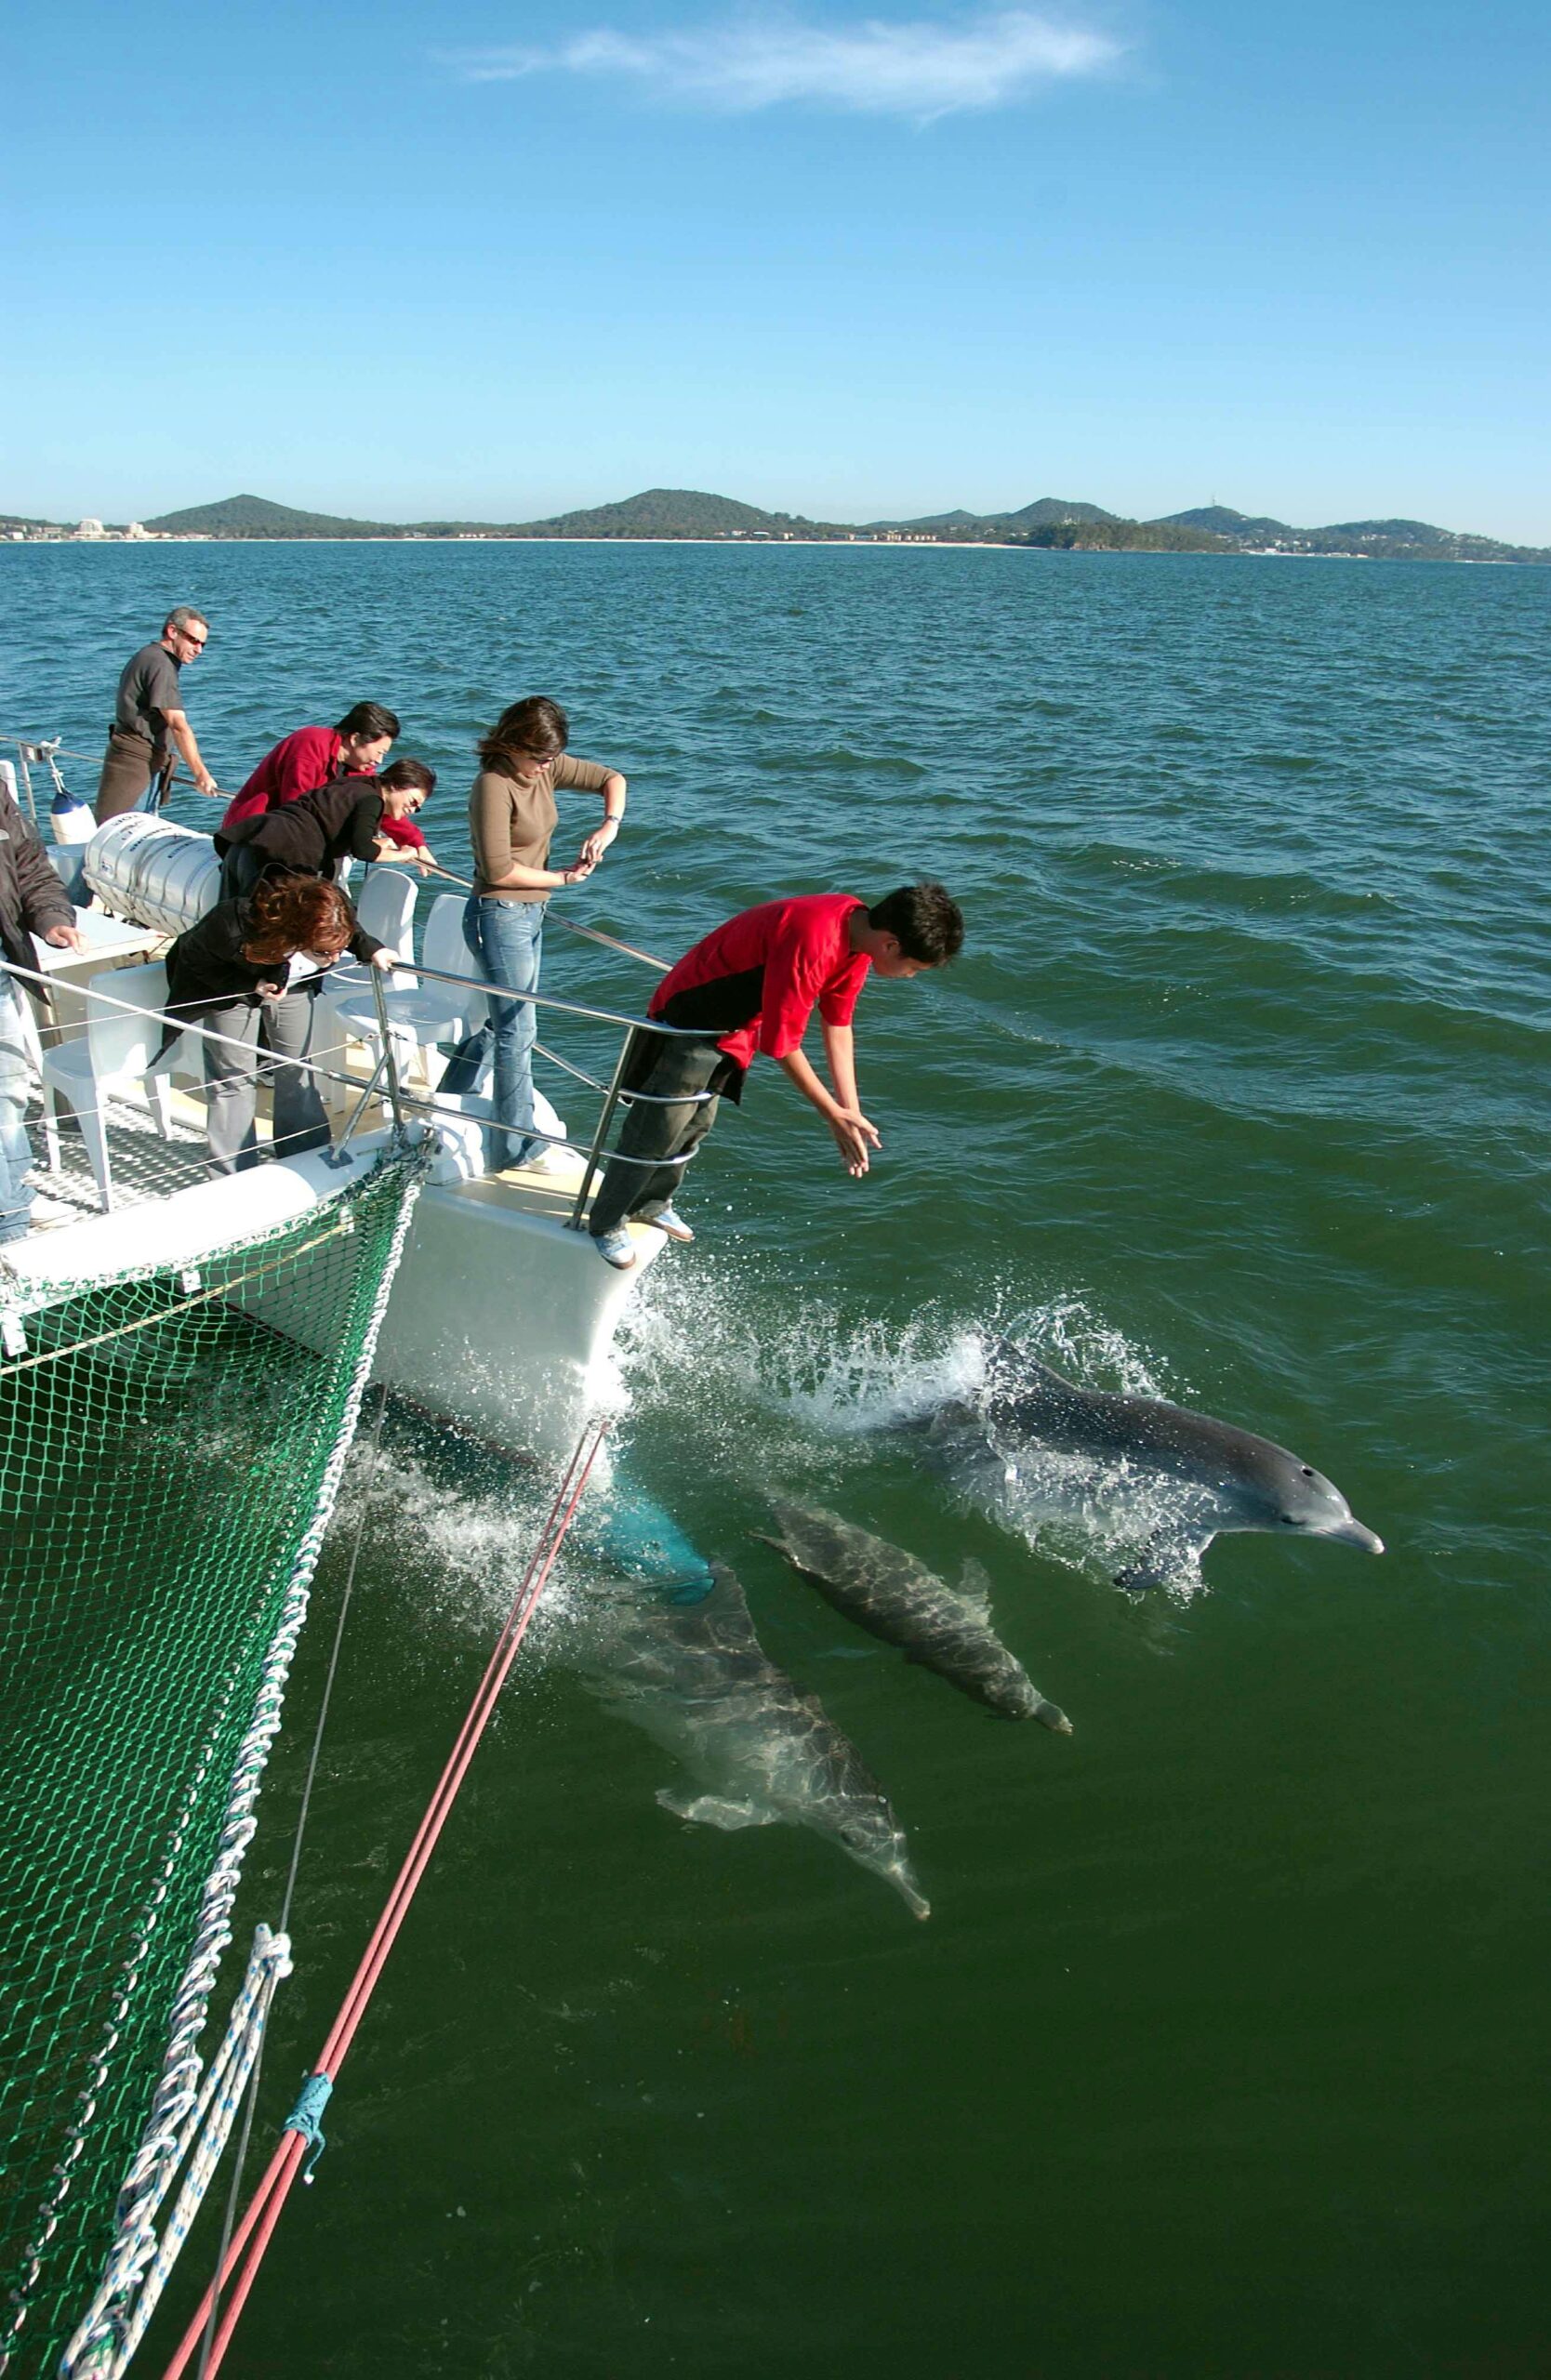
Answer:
[438, 695, 626, 1171]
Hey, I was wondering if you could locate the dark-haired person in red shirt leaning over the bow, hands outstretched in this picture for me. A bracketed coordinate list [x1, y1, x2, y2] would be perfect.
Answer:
[588, 883, 963, 1271]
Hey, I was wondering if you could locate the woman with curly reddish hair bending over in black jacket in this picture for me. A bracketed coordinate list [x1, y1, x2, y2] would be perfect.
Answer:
[166, 876, 397, 1173]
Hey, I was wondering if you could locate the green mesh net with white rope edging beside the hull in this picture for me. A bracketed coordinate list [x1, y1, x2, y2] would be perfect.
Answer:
[0, 1152, 421, 2380]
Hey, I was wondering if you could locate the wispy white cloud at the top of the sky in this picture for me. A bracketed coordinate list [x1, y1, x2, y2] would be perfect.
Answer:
[444, 9, 1120, 122]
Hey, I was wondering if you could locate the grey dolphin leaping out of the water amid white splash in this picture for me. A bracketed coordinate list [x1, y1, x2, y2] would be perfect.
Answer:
[940, 1340, 1385, 1594]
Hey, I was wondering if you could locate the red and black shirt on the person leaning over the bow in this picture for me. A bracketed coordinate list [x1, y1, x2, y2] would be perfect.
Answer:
[647, 892, 873, 1066]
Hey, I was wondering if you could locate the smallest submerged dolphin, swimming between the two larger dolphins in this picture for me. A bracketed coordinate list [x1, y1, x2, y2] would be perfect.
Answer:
[766, 1501, 1070, 1735]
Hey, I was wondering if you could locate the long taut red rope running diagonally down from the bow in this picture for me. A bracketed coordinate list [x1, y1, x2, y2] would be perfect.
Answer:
[162, 1421, 609, 2380]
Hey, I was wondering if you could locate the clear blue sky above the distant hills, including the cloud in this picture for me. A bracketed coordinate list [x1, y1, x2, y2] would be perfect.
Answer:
[0, 0, 1551, 543]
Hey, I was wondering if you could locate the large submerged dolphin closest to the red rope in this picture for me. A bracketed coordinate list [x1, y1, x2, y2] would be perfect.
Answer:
[580, 1564, 933, 1918]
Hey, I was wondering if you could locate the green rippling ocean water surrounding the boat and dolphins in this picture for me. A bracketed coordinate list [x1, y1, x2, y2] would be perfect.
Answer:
[0, 545, 1551, 2380]
